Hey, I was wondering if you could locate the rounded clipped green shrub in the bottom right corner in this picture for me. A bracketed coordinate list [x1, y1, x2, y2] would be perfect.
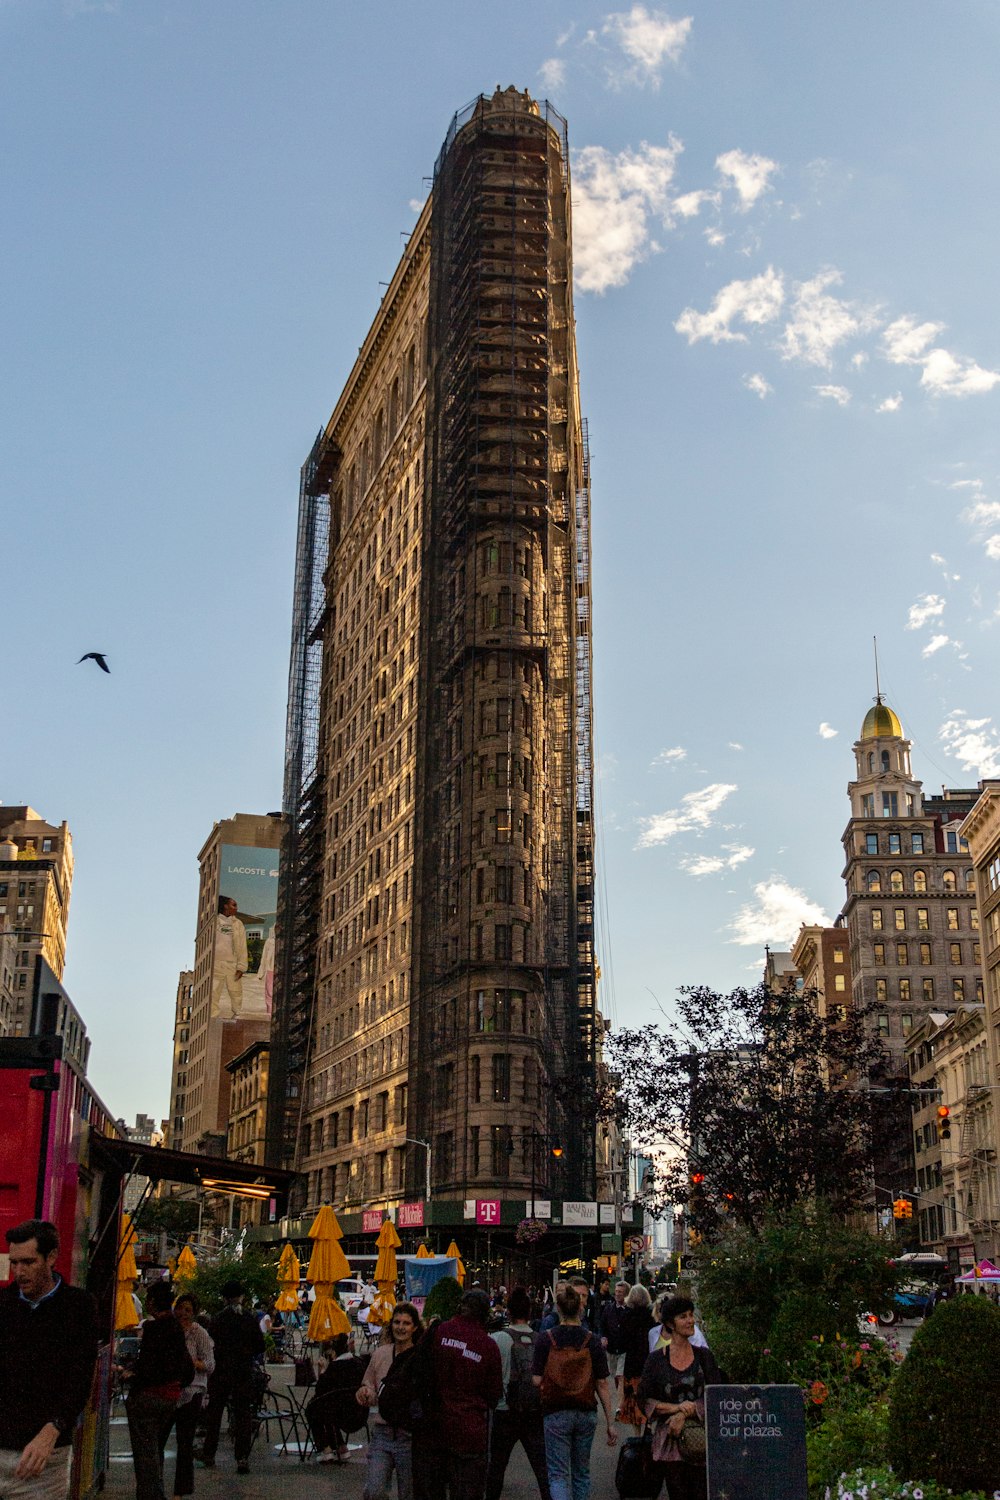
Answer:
[888, 1296, 1000, 1490]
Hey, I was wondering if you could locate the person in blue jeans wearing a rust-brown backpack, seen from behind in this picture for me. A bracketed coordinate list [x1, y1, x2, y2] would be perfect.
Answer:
[531, 1283, 618, 1500]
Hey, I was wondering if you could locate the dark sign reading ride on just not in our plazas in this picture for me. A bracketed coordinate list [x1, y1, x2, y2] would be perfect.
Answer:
[705, 1386, 808, 1500]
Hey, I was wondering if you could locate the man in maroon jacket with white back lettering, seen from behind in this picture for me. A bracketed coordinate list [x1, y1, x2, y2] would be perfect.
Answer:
[414, 1289, 504, 1500]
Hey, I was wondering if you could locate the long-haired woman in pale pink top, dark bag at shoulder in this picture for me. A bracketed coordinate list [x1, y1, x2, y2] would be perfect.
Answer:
[357, 1302, 424, 1500]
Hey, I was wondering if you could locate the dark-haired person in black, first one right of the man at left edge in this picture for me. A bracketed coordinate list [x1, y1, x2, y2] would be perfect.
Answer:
[124, 1281, 195, 1500]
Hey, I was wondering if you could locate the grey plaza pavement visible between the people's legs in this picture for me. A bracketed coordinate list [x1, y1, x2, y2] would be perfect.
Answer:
[103, 1364, 617, 1500]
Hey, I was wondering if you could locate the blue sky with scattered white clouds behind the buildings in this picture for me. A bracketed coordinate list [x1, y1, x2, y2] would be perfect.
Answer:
[0, 0, 1000, 1119]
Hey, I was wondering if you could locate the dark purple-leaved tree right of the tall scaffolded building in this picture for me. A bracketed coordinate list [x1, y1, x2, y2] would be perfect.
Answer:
[609, 984, 885, 1239]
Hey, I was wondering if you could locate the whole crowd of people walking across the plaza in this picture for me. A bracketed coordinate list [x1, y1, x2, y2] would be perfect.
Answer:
[0, 1220, 721, 1500]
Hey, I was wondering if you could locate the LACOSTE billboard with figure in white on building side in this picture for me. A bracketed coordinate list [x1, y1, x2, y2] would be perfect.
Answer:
[211, 845, 279, 1020]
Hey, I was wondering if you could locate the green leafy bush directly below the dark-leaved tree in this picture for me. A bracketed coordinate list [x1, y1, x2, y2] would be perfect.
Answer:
[696, 1202, 900, 1392]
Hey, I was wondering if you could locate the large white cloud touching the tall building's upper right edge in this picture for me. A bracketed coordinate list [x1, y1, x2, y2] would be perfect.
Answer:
[573, 137, 684, 293]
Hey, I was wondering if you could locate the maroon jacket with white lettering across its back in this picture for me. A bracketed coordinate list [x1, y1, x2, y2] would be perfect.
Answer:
[429, 1317, 504, 1454]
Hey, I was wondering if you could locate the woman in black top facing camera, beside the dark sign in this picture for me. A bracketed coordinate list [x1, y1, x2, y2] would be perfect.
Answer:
[637, 1298, 723, 1500]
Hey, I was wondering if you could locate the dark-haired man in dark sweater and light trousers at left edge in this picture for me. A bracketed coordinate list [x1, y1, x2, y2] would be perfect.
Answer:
[0, 1220, 97, 1500]
